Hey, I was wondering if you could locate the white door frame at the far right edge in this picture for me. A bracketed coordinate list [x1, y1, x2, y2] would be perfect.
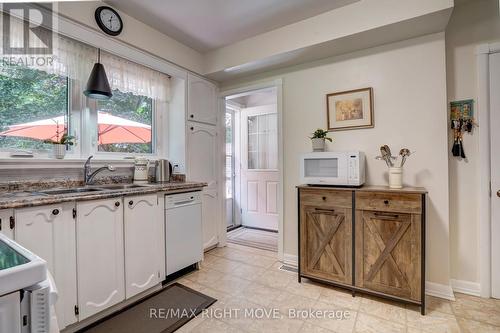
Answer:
[476, 43, 500, 298]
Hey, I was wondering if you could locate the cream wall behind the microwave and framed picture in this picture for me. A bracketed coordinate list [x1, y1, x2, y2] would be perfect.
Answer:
[223, 33, 450, 285]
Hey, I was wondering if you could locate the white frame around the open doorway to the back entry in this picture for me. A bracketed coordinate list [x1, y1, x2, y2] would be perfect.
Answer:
[219, 78, 284, 261]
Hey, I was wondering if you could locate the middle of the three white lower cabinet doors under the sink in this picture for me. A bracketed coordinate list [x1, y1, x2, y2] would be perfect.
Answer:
[76, 198, 125, 320]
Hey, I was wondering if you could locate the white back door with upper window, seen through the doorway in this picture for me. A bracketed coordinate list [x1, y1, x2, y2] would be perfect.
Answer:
[240, 105, 279, 231]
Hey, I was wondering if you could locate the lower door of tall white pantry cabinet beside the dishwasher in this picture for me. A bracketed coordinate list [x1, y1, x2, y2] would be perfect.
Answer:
[187, 122, 220, 249]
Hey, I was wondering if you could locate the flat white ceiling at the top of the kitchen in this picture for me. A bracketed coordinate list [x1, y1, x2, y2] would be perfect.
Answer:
[106, 0, 359, 52]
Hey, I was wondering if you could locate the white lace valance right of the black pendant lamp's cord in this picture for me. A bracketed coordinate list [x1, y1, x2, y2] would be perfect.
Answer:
[101, 51, 170, 103]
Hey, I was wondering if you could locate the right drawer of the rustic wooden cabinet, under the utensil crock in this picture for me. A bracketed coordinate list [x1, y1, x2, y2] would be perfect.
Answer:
[356, 191, 422, 214]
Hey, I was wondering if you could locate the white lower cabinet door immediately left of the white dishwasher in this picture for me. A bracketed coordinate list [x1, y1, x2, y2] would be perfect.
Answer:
[124, 194, 165, 298]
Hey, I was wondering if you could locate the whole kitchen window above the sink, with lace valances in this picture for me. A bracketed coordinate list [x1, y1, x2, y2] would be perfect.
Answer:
[0, 15, 170, 159]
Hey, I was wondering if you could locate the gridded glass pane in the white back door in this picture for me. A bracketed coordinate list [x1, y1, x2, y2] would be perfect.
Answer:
[247, 113, 278, 169]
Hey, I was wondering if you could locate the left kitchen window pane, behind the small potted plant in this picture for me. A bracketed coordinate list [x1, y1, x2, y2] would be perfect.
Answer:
[0, 66, 68, 150]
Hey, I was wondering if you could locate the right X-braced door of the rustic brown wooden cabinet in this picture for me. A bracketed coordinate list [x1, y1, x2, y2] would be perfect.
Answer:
[356, 211, 421, 301]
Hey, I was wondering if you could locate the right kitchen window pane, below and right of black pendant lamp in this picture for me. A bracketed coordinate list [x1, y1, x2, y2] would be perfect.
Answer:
[97, 89, 154, 154]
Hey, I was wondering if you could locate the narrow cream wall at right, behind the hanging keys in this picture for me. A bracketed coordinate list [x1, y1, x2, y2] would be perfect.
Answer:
[446, 0, 500, 283]
